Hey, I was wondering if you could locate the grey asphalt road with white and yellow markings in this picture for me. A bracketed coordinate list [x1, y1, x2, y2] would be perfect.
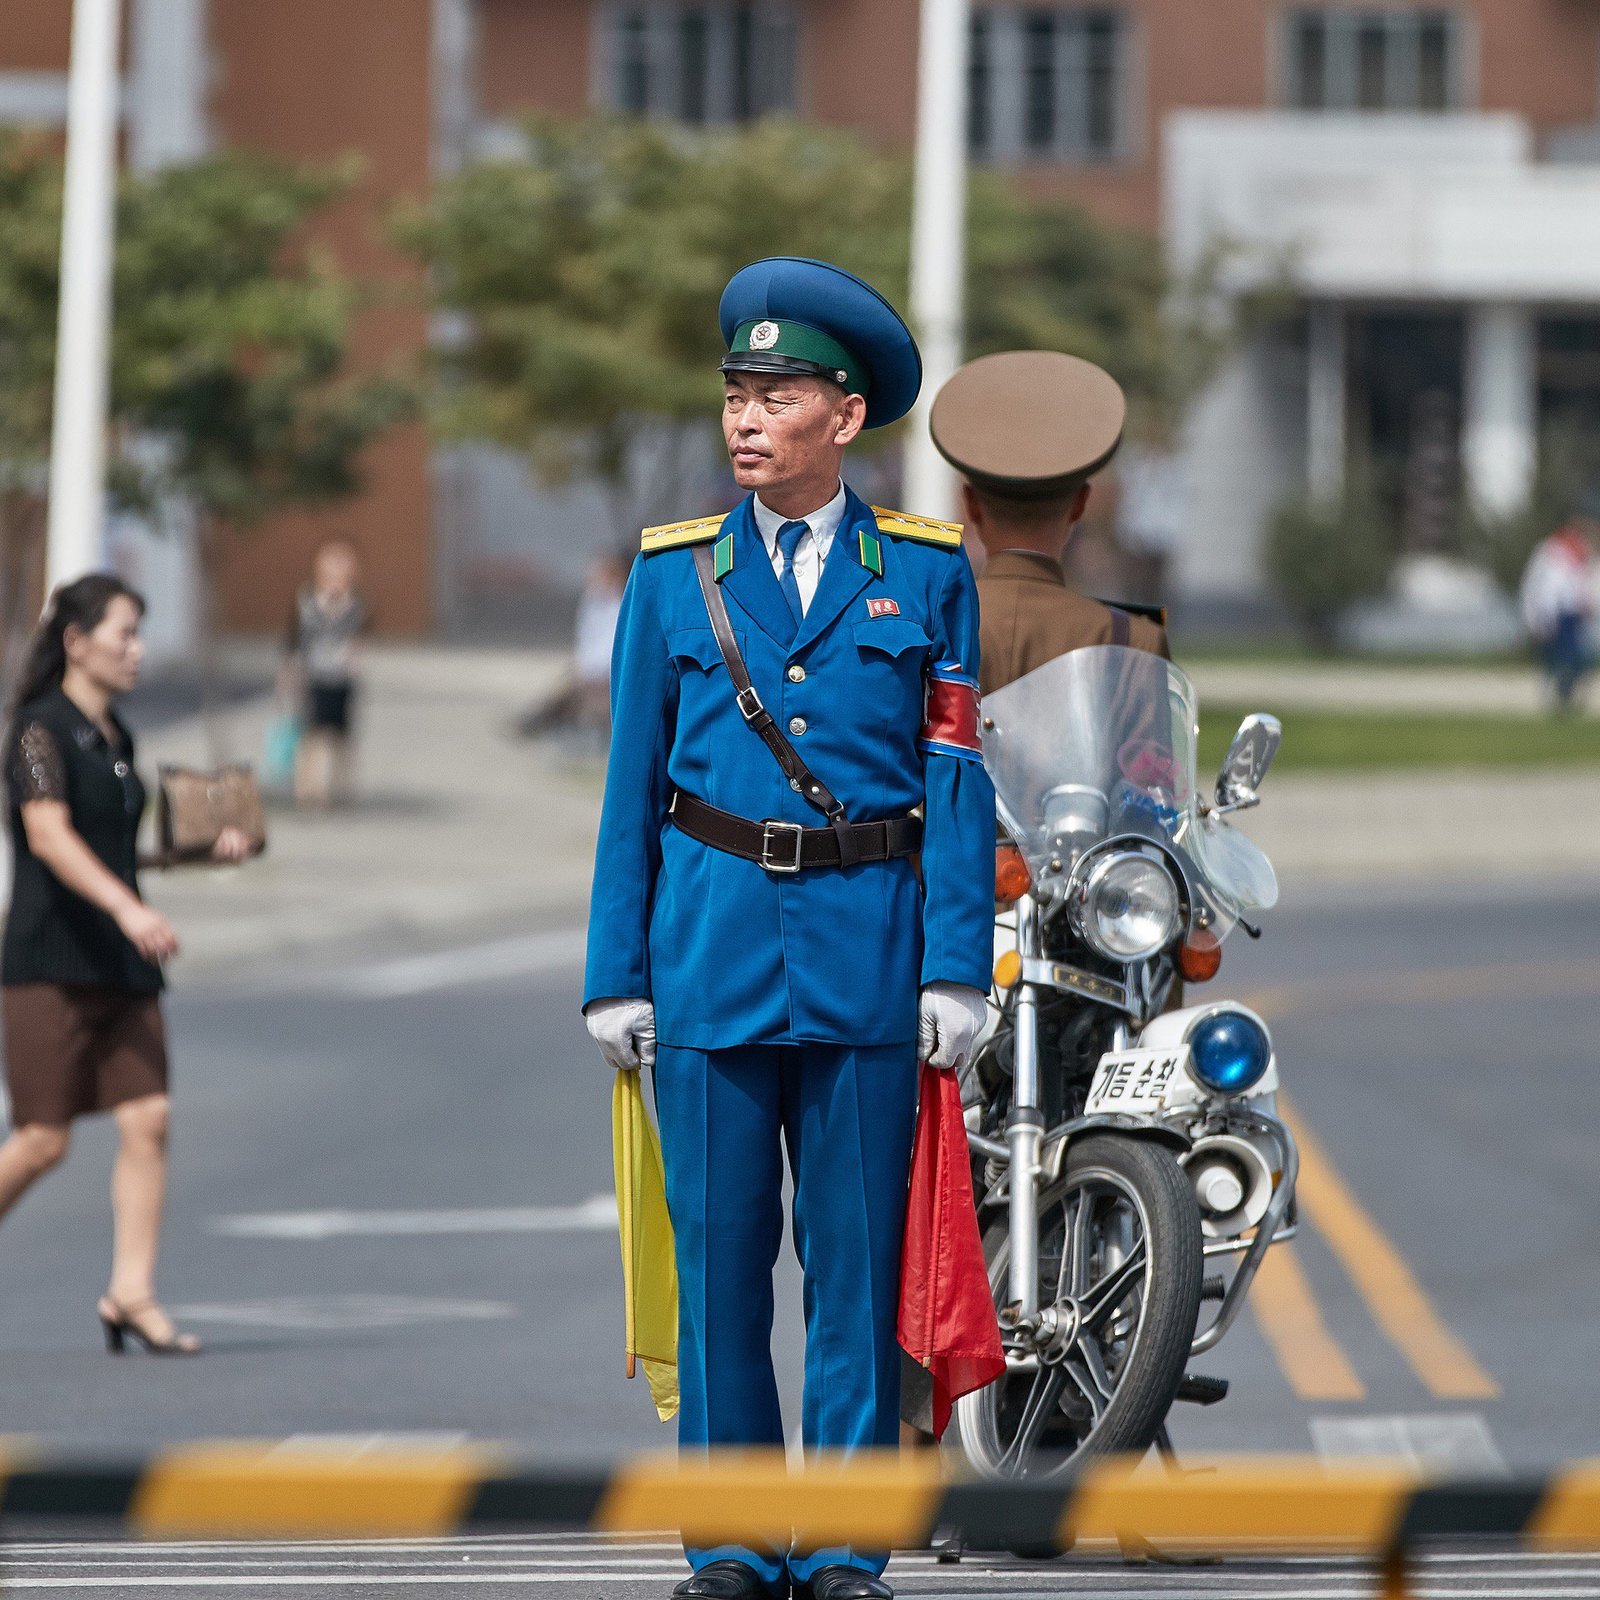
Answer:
[0, 883, 1600, 1600]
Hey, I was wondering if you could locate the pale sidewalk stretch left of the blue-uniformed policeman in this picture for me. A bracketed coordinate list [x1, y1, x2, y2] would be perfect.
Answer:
[139, 646, 602, 973]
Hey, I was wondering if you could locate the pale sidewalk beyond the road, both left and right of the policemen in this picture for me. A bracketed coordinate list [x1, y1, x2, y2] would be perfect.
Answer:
[141, 646, 1600, 976]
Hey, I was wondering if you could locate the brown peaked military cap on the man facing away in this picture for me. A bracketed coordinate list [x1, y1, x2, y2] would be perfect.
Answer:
[930, 350, 1128, 499]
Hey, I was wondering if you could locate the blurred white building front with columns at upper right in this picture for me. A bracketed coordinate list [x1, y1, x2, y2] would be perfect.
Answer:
[1163, 110, 1600, 617]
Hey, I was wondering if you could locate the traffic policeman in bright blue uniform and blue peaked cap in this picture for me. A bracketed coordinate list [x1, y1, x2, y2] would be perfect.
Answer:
[584, 258, 994, 1600]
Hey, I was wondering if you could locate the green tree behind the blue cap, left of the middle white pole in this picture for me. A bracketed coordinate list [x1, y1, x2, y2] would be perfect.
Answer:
[400, 120, 906, 531]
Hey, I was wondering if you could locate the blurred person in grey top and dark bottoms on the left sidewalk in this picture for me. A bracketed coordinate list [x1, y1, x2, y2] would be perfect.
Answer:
[283, 539, 371, 808]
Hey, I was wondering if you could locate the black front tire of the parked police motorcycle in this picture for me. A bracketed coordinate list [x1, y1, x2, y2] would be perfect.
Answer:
[950, 1134, 1203, 1480]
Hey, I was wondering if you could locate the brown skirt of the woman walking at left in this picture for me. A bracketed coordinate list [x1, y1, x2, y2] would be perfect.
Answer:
[0, 984, 166, 1128]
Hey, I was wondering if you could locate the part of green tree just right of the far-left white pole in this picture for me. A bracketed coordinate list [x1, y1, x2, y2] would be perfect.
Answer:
[112, 154, 411, 640]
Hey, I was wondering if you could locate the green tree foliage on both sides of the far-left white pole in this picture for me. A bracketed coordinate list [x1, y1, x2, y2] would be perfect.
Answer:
[0, 138, 411, 707]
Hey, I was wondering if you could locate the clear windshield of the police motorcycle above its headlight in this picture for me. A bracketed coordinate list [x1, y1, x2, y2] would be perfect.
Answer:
[982, 645, 1278, 933]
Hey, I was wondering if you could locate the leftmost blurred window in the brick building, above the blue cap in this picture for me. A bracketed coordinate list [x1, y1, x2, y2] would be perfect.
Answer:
[600, 0, 795, 128]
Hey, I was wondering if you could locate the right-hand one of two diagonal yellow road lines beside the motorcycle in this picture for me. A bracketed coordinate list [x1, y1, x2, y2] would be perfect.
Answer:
[1278, 1099, 1499, 1400]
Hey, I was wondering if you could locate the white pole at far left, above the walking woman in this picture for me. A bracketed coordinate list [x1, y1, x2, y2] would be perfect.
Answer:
[45, 0, 122, 589]
